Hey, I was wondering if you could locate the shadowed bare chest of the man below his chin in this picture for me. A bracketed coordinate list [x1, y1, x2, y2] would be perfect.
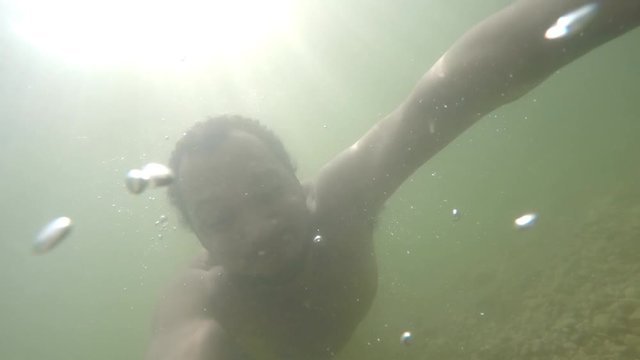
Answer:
[216, 231, 377, 360]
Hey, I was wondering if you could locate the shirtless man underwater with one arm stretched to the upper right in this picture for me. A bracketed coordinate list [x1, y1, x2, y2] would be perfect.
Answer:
[147, 0, 640, 360]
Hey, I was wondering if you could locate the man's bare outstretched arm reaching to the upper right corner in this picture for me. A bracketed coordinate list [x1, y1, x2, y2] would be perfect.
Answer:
[317, 0, 640, 215]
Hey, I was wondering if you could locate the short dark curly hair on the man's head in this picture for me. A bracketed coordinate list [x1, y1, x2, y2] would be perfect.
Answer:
[167, 114, 296, 223]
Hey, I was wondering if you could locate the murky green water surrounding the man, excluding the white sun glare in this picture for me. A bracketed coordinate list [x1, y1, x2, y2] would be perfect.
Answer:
[0, 0, 640, 360]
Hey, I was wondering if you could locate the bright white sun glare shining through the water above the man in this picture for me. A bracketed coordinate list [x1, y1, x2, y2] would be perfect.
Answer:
[12, 0, 295, 69]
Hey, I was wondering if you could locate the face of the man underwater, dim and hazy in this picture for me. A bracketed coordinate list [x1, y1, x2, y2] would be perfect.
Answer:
[178, 131, 309, 277]
